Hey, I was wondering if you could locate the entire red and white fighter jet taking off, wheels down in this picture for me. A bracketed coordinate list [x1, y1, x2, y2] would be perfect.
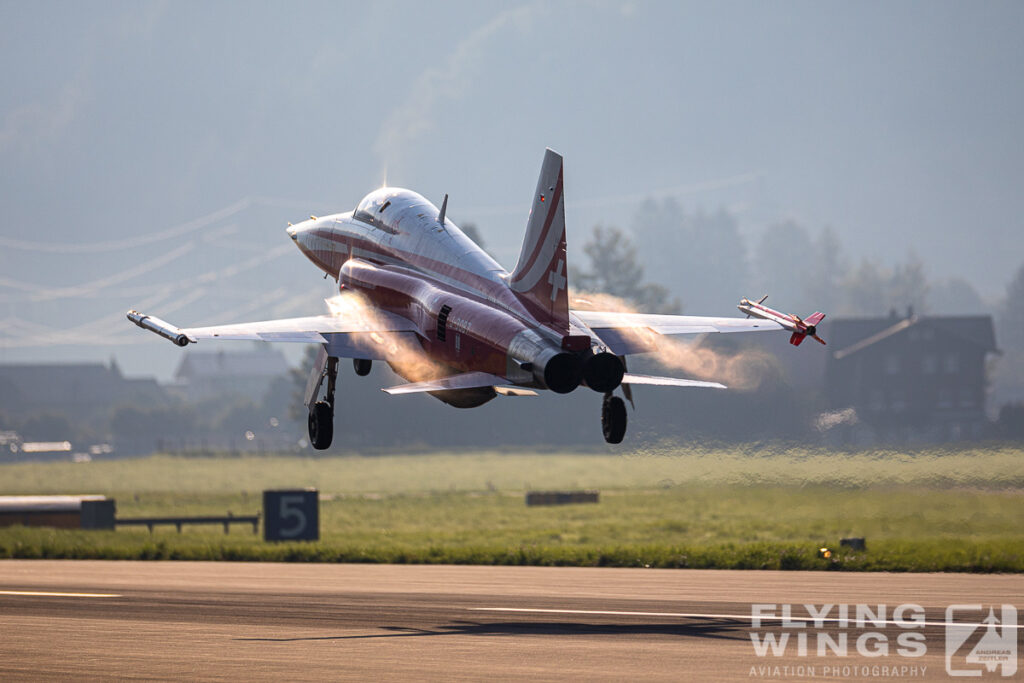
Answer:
[128, 150, 813, 449]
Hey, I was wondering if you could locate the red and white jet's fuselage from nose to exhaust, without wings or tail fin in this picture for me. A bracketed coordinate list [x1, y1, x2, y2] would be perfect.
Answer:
[288, 187, 598, 408]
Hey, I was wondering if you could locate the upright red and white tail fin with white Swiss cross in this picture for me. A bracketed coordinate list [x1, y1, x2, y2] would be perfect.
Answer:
[509, 148, 569, 334]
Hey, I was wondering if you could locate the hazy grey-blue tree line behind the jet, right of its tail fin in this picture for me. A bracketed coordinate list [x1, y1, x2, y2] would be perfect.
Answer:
[574, 194, 995, 316]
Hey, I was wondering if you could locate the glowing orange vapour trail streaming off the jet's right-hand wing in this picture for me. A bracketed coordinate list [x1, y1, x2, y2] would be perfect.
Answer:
[569, 291, 775, 391]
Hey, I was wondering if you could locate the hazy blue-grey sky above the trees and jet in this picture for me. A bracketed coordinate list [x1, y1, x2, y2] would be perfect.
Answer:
[0, 1, 1024, 376]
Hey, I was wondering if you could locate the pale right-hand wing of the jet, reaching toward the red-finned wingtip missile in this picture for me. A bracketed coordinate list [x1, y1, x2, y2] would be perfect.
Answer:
[572, 310, 784, 355]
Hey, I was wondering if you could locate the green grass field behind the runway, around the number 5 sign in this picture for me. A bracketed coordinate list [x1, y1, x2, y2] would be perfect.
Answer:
[0, 447, 1024, 571]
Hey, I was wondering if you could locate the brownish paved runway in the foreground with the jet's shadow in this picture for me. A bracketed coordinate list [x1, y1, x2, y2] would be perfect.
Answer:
[0, 560, 1024, 681]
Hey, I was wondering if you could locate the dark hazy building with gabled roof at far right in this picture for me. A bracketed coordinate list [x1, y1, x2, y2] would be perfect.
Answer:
[824, 311, 998, 442]
